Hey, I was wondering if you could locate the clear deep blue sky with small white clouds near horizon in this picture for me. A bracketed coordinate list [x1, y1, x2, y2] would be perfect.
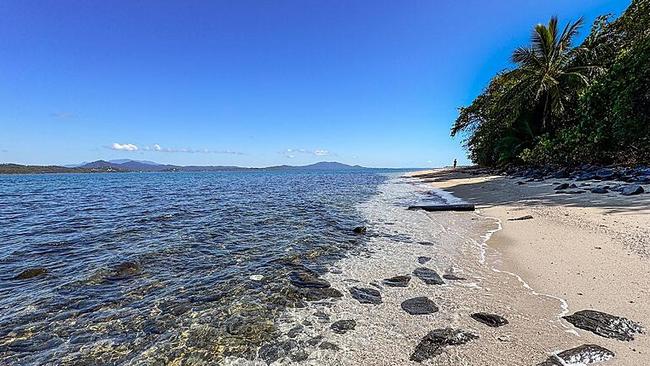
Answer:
[0, 0, 629, 167]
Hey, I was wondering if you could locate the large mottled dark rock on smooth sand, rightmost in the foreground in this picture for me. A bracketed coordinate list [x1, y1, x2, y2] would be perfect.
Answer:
[562, 310, 644, 341]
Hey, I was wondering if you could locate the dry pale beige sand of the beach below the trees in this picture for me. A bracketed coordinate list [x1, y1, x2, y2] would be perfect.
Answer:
[411, 169, 650, 365]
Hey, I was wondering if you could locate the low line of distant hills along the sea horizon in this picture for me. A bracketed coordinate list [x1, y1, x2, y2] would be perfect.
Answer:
[0, 159, 368, 174]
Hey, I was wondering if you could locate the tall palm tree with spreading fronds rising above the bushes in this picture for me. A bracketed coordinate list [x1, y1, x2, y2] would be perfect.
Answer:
[508, 17, 597, 130]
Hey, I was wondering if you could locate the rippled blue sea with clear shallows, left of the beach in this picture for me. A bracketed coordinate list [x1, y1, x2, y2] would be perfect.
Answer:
[0, 172, 386, 364]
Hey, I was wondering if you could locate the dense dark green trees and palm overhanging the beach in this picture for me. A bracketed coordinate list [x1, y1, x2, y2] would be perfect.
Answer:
[451, 0, 650, 166]
